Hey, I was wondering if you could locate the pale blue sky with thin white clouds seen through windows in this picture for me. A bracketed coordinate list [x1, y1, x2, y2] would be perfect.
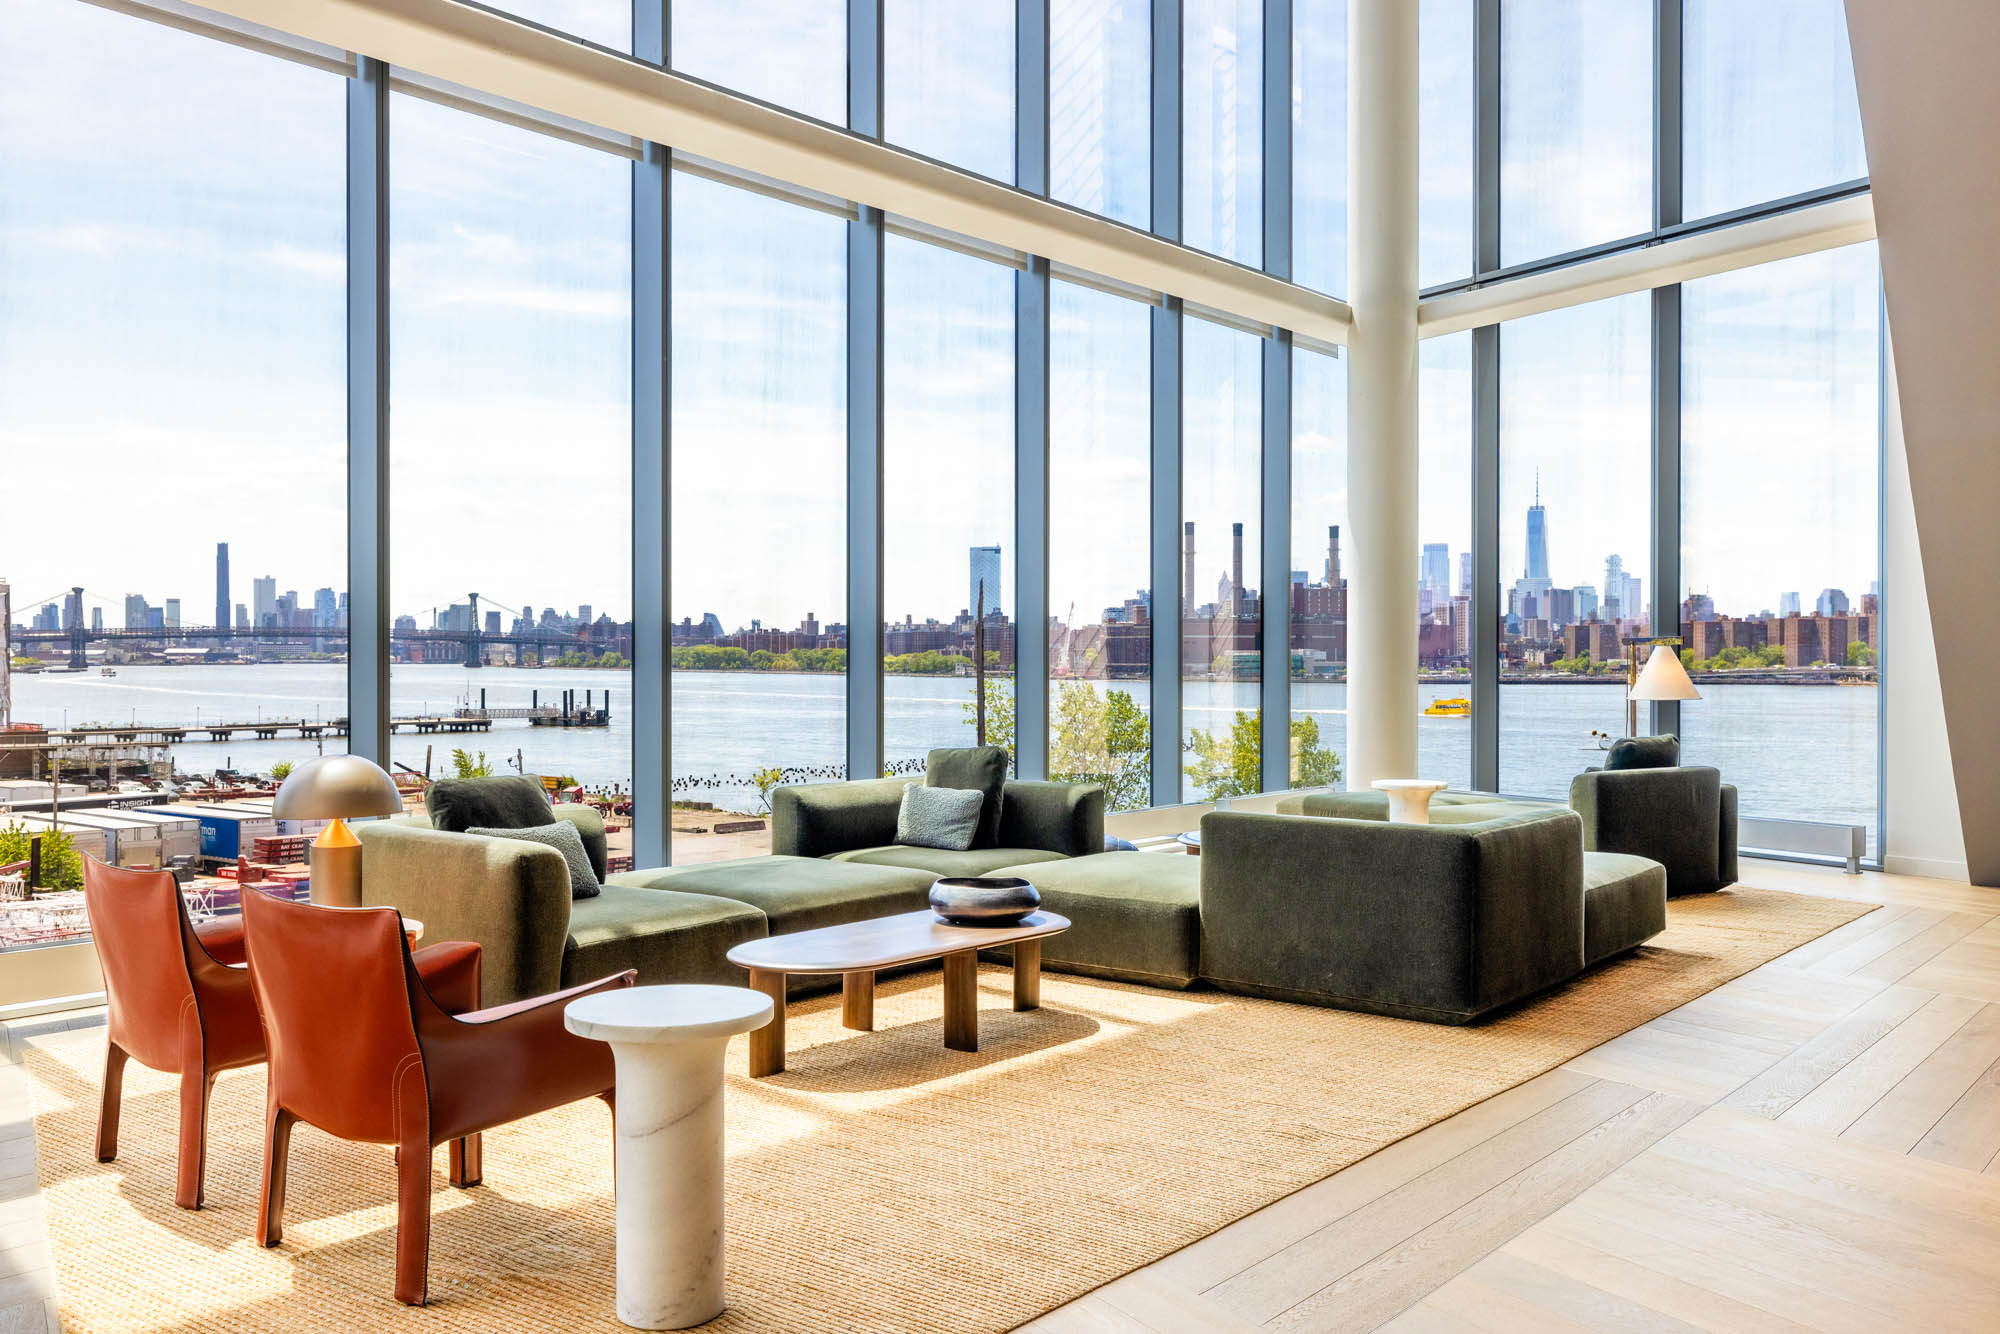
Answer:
[0, 0, 1878, 628]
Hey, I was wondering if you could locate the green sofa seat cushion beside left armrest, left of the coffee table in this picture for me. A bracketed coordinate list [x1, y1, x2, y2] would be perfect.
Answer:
[562, 884, 766, 986]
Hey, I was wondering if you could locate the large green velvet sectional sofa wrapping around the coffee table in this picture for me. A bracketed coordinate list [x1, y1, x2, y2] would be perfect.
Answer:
[358, 752, 1666, 1024]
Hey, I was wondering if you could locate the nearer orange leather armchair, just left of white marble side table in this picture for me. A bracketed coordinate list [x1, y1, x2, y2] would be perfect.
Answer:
[244, 890, 638, 1306]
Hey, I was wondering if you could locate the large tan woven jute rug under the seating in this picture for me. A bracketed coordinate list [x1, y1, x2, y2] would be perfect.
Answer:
[28, 888, 1872, 1334]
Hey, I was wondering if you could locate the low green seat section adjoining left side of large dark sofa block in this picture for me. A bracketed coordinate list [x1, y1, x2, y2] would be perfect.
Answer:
[1000, 852, 1202, 986]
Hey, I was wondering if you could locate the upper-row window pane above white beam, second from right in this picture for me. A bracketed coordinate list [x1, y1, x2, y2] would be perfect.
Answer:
[1500, 0, 1652, 264]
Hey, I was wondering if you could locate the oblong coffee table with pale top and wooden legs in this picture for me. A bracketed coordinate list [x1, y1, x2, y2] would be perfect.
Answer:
[728, 908, 1070, 1078]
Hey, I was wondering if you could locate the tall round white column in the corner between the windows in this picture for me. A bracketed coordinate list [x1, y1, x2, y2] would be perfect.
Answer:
[1344, 0, 1418, 792]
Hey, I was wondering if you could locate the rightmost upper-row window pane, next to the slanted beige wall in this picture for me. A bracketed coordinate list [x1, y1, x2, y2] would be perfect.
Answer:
[1680, 0, 1868, 218]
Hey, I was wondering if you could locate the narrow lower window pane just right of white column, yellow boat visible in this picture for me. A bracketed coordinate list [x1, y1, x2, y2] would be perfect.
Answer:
[1416, 334, 1474, 788]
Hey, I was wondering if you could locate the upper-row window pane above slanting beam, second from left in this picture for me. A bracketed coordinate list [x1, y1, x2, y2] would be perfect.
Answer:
[668, 0, 848, 124]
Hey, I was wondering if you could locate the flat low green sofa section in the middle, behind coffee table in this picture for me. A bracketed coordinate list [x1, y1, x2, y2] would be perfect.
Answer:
[612, 848, 932, 940]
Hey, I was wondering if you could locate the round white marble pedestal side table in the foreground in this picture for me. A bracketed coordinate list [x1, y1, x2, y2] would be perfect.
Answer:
[562, 986, 772, 1330]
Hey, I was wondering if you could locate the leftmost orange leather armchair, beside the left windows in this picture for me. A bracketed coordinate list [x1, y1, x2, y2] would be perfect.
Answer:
[84, 856, 480, 1208]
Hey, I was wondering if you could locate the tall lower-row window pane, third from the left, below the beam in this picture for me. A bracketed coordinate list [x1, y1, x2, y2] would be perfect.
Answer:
[668, 172, 848, 862]
